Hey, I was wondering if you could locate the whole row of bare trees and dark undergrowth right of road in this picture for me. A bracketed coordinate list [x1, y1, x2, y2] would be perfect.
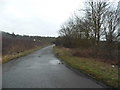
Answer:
[56, 0, 120, 62]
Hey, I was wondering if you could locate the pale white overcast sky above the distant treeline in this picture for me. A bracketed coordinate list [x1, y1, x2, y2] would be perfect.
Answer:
[0, 0, 118, 36]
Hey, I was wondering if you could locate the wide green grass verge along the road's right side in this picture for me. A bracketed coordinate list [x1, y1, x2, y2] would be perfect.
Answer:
[54, 47, 118, 88]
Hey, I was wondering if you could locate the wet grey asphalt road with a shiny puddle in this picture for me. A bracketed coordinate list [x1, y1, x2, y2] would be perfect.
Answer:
[2, 45, 107, 88]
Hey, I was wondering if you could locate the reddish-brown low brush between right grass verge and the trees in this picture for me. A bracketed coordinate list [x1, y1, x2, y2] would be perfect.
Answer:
[71, 48, 120, 65]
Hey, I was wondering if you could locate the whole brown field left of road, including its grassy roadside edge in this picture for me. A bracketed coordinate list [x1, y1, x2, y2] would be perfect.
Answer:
[2, 32, 54, 63]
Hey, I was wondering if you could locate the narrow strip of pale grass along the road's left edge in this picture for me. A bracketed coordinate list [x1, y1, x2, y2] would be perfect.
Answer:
[2, 45, 47, 64]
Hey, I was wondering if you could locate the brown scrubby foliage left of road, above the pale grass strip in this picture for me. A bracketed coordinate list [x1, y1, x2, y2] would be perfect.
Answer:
[2, 32, 54, 56]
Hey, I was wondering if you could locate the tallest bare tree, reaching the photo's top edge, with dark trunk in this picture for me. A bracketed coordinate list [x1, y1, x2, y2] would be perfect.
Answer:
[88, 1, 108, 44]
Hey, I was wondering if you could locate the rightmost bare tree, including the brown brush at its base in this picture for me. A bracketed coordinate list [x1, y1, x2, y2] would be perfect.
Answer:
[102, 4, 120, 59]
